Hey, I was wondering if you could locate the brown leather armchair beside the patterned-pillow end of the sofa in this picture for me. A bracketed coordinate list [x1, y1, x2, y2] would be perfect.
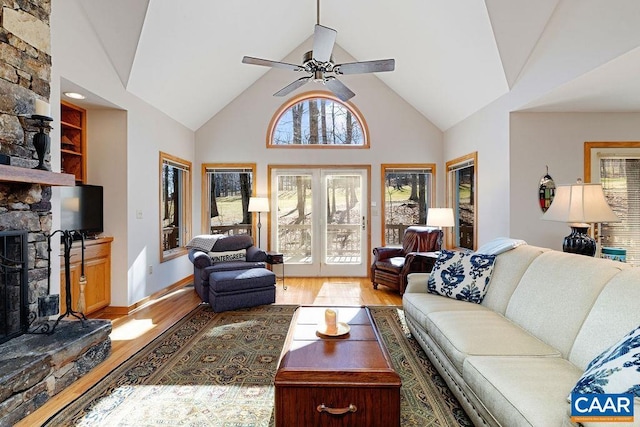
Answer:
[371, 225, 442, 295]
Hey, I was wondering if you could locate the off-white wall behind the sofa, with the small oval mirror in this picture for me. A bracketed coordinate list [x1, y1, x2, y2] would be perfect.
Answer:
[509, 113, 640, 250]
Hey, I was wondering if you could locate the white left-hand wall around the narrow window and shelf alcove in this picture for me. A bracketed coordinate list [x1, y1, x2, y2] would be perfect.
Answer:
[51, 0, 197, 306]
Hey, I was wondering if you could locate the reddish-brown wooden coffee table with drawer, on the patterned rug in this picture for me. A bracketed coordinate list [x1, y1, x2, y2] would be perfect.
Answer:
[275, 306, 401, 427]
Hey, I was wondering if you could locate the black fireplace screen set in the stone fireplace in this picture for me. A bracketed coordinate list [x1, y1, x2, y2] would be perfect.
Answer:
[0, 231, 29, 343]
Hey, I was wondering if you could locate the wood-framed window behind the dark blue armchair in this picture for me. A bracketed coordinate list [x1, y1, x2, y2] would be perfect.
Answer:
[202, 163, 256, 235]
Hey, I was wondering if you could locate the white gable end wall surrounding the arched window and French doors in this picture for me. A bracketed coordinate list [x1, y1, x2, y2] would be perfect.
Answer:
[194, 40, 444, 247]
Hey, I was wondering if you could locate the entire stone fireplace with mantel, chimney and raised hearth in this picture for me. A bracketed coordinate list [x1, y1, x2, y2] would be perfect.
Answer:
[0, 0, 111, 425]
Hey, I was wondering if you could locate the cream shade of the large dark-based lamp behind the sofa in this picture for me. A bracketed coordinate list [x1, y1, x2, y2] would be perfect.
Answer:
[542, 182, 620, 223]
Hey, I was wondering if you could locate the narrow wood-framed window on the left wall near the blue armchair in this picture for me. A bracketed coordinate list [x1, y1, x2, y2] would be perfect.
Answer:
[160, 152, 191, 262]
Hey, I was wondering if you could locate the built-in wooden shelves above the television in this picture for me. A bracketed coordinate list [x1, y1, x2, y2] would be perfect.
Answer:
[60, 101, 87, 184]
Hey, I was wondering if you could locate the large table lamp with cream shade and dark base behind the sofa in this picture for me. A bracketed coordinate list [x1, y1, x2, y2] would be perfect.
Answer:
[542, 179, 620, 256]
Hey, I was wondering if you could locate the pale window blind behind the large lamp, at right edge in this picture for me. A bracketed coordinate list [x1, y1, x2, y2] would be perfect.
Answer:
[600, 156, 640, 266]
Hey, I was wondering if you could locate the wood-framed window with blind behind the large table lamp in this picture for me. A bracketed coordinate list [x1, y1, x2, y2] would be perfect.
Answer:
[585, 142, 640, 266]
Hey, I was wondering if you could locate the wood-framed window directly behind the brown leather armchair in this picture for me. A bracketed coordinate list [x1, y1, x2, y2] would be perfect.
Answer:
[380, 164, 436, 245]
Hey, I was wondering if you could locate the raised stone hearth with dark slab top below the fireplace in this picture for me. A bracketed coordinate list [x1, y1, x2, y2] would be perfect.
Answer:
[0, 319, 111, 426]
